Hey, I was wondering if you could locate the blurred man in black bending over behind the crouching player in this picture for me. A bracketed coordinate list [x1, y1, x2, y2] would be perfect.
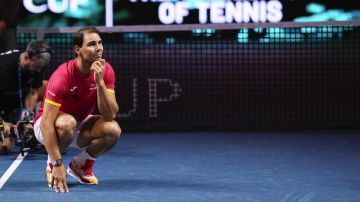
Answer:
[0, 40, 51, 154]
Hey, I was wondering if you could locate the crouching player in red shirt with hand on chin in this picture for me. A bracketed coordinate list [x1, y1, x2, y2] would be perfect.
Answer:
[34, 27, 121, 192]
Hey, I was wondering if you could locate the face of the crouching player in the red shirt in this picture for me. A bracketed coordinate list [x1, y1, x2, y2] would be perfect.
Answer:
[80, 33, 104, 63]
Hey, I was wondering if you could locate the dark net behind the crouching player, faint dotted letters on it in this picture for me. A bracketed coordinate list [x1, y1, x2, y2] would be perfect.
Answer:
[16, 26, 360, 131]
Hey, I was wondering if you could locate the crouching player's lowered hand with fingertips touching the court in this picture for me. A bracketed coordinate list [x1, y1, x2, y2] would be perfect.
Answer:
[51, 165, 69, 192]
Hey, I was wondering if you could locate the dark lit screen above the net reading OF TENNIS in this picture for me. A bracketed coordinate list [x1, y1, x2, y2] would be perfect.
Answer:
[19, 0, 360, 27]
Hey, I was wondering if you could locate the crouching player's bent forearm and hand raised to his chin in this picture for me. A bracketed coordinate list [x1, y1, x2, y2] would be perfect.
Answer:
[92, 61, 119, 121]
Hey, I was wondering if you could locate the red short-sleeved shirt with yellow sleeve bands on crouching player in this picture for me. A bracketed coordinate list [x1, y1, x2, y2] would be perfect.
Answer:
[35, 58, 115, 122]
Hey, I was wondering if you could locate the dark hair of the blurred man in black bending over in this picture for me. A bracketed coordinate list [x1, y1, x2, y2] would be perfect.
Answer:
[26, 40, 51, 67]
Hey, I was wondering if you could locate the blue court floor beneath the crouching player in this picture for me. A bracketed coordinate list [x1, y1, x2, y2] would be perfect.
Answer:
[0, 132, 360, 202]
